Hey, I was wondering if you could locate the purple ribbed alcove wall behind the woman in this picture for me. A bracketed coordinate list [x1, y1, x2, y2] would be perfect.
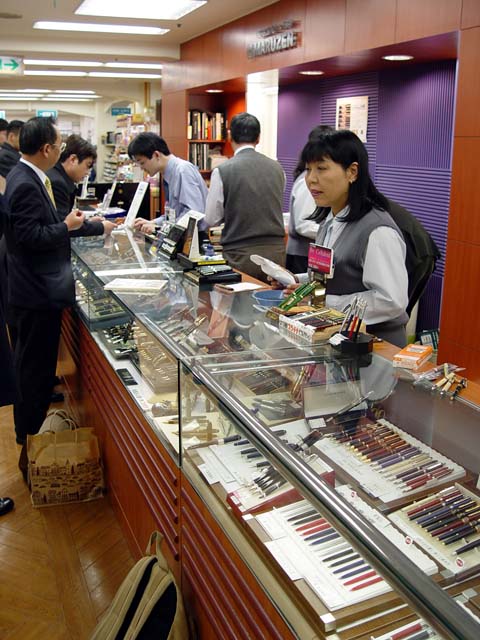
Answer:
[278, 61, 456, 331]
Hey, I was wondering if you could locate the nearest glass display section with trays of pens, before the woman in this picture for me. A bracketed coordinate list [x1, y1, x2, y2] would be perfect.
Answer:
[180, 346, 480, 639]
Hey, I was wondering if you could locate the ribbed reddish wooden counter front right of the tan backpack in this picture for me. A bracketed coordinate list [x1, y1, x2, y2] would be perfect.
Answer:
[181, 477, 293, 640]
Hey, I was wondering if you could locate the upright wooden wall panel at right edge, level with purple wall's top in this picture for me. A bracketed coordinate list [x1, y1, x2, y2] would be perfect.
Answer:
[455, 27, 480, 136]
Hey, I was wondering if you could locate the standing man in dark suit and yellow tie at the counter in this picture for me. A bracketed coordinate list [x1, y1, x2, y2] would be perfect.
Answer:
[5, 118, 85, 444]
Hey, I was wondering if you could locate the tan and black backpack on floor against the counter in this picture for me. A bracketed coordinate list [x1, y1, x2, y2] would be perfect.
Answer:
[91, 531, 189, 640]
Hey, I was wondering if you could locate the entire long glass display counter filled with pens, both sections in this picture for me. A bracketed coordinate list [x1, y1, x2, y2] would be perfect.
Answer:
[72, 234, 480, 640]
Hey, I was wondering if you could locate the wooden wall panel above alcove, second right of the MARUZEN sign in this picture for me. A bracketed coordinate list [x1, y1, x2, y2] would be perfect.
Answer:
[345, 0, 396, 52]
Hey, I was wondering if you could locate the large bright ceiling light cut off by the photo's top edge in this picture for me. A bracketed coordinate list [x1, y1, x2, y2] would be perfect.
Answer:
[75, 0, 207, 20]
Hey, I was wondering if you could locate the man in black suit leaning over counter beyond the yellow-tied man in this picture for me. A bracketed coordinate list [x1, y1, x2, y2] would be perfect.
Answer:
[47, 134, 116, 236]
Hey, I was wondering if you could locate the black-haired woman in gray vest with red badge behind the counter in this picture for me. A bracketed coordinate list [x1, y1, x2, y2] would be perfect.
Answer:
[280, 130, 408, 347]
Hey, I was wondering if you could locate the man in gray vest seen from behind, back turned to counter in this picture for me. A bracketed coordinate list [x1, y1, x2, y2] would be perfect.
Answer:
[205, 113, 285, 281]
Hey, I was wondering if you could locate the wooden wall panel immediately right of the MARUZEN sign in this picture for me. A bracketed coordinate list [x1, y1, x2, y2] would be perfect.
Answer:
[304, 0, 346, 61]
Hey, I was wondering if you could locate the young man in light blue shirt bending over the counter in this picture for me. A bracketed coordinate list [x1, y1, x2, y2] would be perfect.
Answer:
[128, 131, 208, 233]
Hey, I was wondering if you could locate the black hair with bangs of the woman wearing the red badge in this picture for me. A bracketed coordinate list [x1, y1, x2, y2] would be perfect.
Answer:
[301, 129, 388, 222]
